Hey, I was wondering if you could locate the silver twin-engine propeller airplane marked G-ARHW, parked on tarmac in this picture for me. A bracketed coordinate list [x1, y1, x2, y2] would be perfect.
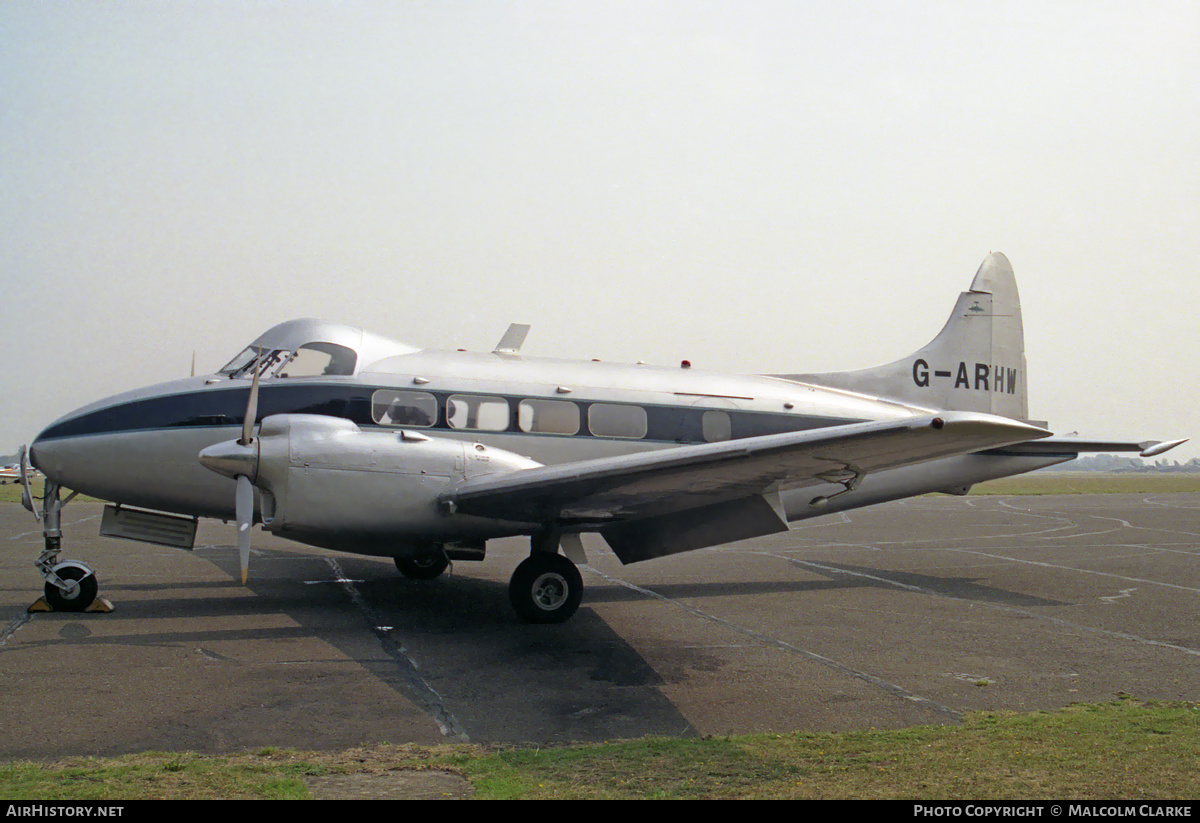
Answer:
[22, 253, 1181, 623]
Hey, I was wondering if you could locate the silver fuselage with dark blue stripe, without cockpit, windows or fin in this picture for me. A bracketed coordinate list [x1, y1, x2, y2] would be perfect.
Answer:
[31, 350, 1058, 556]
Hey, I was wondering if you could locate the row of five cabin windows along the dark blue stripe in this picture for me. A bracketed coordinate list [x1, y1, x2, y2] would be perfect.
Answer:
[371, 389, 733, 443]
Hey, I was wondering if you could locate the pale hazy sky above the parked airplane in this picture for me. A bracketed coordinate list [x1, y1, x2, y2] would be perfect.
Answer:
[0, 0, 1200, 459]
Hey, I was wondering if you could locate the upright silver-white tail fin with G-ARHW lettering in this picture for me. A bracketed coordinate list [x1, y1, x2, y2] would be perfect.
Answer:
[781, 252, 1028, 420]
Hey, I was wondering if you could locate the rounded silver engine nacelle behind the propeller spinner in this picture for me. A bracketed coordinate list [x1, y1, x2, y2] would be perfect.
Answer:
[253, 414, 540, 554]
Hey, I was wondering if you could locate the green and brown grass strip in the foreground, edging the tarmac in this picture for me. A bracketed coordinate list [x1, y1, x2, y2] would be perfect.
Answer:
[0, 698, 1200, 800]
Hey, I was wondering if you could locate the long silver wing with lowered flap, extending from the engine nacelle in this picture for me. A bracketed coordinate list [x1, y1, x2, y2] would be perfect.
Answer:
[442, 412, 1050, 563]
